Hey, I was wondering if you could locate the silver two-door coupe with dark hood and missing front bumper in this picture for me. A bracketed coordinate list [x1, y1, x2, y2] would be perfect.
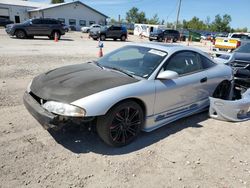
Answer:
[24, 43, 232, 147]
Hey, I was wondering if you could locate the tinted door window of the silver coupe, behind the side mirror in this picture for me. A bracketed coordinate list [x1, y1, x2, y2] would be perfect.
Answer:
[163, 51, 202, 75]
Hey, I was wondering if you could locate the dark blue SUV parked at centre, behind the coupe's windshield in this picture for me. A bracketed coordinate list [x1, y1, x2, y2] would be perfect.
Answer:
[89, 25, 128, 41]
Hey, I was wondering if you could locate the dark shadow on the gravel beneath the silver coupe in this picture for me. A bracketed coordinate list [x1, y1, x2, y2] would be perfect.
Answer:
[50, 112, 208, 155]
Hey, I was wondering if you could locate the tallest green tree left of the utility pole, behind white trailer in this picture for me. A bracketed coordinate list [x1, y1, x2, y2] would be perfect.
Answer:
[126, 7, 147, 23]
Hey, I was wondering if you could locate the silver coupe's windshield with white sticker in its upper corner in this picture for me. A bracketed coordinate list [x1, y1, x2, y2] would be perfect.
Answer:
[98, 46, 167, 78]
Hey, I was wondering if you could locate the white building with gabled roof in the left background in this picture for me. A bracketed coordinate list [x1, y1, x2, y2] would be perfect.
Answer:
[0, 0, 108, 30]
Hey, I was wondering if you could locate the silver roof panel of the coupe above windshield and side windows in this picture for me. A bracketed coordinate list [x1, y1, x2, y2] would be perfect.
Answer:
[128, 42, 204, 56]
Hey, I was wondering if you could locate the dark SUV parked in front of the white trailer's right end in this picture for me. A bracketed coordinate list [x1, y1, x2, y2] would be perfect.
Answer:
[149, 29, 180, 42]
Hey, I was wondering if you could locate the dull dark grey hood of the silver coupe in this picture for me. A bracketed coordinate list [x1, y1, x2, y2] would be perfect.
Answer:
[30, 63, 139, 103]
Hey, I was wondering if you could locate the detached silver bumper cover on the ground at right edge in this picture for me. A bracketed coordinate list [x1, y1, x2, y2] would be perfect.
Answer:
[209, 89, 250, 122]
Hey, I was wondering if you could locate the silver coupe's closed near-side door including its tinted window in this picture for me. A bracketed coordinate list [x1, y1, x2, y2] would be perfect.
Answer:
[155, 51, 209, 115]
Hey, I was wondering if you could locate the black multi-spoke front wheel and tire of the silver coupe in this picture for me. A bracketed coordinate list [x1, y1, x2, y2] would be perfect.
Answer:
[96, 101, 145, 147]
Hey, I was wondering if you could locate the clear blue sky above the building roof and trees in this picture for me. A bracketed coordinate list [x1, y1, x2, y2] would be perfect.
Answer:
[30, 0, 250, 29]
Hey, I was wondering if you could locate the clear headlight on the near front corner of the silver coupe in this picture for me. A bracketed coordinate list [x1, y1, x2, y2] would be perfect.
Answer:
[43, 101, 86, 117]
